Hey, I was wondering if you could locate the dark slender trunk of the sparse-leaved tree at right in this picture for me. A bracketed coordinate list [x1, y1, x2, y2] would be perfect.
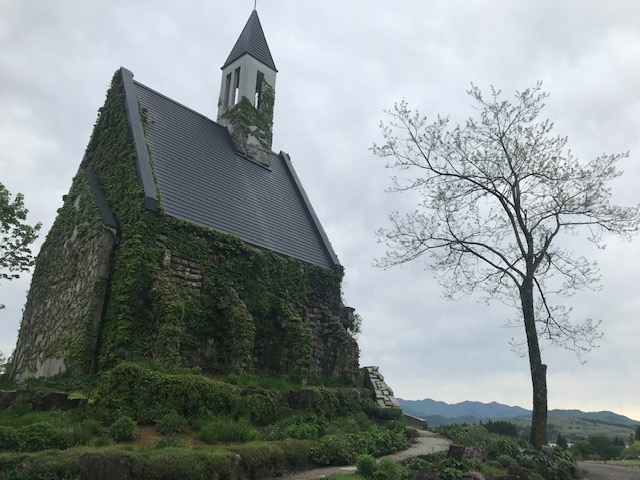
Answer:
[520, 279, 547, 449]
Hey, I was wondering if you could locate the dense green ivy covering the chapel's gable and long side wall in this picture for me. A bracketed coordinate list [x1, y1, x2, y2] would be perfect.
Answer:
[11, 72, 358, 380]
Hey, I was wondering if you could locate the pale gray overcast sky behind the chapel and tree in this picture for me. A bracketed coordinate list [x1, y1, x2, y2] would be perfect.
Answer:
[0, 0, 640, 420]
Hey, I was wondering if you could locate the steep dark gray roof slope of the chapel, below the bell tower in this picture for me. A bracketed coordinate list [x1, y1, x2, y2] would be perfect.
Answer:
[129, 77, 341, 269]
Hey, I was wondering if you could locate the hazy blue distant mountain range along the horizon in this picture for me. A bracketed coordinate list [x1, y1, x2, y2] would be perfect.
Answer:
[398, 398, 640, 427]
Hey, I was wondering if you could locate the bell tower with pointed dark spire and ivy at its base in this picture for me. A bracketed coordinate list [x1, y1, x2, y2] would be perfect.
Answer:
[218, 10, 278, 166]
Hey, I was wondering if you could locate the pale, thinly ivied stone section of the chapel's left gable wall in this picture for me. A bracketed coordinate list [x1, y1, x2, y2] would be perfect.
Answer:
[10, 176, 115, 380]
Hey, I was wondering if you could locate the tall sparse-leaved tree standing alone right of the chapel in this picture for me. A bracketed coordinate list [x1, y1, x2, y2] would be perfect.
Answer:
[373, 83, 640, 447]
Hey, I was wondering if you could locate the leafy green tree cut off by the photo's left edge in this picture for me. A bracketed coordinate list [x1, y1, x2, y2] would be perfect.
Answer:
[0, 183, 41, 308]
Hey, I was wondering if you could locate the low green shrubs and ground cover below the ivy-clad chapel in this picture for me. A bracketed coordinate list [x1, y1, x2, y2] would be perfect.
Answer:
[0, 365, 410, 480]
